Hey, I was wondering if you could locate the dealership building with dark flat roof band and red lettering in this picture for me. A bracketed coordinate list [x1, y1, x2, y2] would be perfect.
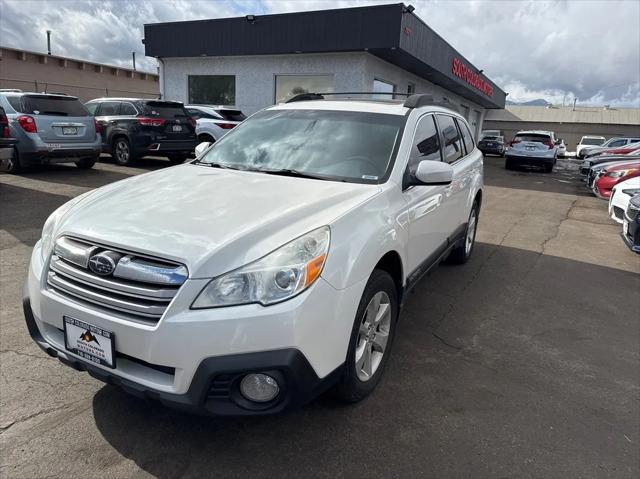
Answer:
[143, 3, 506, 135]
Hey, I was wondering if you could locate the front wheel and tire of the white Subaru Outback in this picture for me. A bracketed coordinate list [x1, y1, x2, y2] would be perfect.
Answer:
[336, 269, 398, 402]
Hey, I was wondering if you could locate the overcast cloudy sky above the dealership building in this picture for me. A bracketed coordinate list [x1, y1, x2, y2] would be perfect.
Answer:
[0, 0, 640, 107]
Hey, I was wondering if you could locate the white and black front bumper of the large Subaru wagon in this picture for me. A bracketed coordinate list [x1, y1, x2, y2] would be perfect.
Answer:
[24, 243, 364, 415]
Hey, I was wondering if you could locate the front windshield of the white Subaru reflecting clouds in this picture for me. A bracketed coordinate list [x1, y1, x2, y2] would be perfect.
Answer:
[197, 110, 404, 183]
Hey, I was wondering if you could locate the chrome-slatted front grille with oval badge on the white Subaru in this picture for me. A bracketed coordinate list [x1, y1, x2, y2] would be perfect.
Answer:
[47, 237, 187, 323]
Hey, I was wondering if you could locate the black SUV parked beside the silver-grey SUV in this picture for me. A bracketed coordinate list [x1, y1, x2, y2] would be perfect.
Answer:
[85, 98, 196, 165]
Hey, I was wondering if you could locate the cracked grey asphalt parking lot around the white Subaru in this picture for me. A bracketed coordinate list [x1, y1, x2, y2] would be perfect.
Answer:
[0, 157, 640, 478]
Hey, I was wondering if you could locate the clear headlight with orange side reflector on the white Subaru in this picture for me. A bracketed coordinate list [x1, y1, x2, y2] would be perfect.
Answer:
[191, 226, 331, 309]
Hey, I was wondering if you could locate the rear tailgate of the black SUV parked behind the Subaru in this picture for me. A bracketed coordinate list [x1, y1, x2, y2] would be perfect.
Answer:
[141, 100, 196, 141]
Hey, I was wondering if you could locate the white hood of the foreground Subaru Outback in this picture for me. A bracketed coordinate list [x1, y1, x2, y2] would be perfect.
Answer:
[55, 164, 381, 278]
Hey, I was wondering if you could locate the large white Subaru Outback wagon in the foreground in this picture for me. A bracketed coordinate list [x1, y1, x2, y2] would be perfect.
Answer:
[23, 95, 483, 415]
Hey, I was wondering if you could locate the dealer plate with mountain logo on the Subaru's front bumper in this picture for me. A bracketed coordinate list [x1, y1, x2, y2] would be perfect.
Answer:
[64, 316, 116, 368]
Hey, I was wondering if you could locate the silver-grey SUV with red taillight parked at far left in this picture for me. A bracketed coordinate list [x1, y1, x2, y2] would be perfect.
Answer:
[0, 91, 102, 173]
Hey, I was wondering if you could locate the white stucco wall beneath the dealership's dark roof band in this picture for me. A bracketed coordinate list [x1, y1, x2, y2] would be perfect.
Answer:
[160, 52, 485, 131]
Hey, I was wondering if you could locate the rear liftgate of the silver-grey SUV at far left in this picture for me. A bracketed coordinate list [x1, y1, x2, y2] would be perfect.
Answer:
[21, 94, 96, 144]
